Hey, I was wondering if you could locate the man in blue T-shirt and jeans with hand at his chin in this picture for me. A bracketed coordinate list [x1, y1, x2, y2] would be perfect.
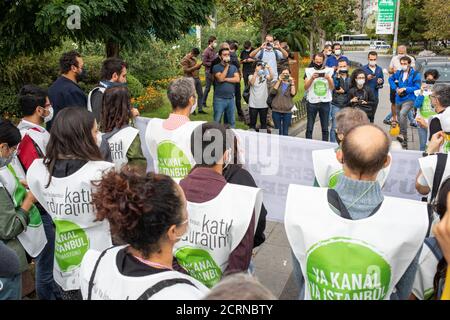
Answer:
[212, 48, 241, 128]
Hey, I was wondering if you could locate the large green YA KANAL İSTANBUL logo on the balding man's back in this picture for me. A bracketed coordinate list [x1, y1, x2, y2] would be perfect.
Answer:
[306, 238, 391, 300]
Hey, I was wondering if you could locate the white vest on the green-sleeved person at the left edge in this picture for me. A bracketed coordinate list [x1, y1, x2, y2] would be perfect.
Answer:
[0, 165, 47, 258]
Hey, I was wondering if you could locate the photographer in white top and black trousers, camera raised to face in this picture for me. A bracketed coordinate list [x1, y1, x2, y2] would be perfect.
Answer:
[248, 61, 273, 130]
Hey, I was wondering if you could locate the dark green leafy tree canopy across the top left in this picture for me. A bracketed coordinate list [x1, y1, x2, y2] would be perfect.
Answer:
[0, 0, 214, 57]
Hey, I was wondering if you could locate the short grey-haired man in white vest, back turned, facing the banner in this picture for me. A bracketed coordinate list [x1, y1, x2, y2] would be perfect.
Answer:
[145, 77, 204, 182]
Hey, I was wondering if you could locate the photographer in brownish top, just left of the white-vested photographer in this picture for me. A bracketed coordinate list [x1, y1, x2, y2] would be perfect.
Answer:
[270, 68, 297, 136]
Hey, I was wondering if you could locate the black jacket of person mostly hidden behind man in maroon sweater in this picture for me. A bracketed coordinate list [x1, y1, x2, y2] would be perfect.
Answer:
[223, 164, 267, 248]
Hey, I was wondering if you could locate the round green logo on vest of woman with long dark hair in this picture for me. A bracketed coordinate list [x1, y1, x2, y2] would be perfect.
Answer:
[54, 220, 89, 272]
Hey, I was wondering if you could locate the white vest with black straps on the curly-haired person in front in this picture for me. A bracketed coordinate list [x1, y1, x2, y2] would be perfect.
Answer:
[80, 246, 209, 300]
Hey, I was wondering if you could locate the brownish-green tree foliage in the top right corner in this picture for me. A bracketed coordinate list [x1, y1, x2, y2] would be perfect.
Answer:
[423, 0, 450, 40]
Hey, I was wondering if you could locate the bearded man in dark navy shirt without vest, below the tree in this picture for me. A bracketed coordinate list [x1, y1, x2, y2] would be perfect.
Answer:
[47, 51, 87, 131]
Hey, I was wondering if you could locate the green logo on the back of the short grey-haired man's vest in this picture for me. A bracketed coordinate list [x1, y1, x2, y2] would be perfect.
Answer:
[157, 141, 191, 179]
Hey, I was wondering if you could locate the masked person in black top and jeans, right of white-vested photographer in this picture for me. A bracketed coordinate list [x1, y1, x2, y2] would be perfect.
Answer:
[330, 59, 350, 142]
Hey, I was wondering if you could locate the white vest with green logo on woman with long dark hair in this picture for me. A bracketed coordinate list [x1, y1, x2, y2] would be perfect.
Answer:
[27, 159, 114, 291]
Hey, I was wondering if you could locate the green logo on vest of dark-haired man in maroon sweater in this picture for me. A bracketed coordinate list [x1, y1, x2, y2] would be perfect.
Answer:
[175, 247, 222, 288]
